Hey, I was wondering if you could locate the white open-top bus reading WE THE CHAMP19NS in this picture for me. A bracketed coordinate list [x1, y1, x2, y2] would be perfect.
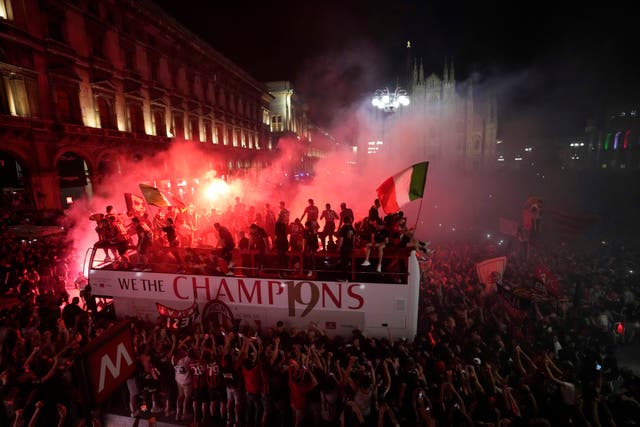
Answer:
[86, 247, 420, 339]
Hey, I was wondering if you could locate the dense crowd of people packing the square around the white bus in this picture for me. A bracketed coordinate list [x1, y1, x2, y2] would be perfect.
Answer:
[0, 204, 640, 427]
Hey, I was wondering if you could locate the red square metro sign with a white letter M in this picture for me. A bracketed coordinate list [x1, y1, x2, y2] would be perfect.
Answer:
[80, 322, 136, 404]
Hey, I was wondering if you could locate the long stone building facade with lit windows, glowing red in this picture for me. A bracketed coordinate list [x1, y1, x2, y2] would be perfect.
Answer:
[0, 0, 273, 209]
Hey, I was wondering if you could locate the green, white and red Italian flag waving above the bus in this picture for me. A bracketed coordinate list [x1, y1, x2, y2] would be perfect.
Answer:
[376, 162, 429, 214]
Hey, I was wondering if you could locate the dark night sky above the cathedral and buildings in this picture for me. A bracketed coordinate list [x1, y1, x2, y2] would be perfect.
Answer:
[156, 0, 640, 141]
